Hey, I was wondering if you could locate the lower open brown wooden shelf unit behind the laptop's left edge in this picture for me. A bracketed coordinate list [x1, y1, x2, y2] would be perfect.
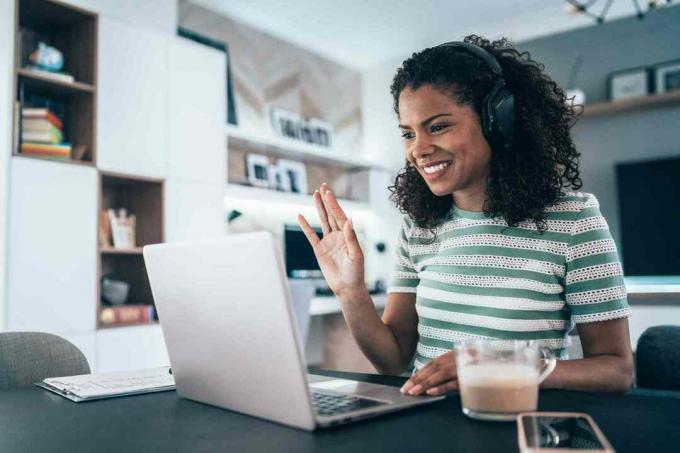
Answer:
[97, 172, 164, 328]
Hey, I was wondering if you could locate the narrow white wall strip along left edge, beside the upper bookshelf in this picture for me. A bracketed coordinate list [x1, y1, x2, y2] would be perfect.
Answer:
[0, 0, 14, 331]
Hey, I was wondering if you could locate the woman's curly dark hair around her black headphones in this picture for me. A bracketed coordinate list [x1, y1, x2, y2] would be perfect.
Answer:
[389, 35, 583, 232]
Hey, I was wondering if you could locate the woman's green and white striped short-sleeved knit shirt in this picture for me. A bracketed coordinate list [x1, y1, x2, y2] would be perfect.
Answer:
[388, 193, 630, 369]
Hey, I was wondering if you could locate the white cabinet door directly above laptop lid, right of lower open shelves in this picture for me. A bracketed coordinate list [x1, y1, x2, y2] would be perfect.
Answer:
[165, 179, 226, 242]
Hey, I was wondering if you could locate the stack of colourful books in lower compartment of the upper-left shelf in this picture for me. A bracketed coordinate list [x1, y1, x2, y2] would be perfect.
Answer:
[21, 107, 71, 160]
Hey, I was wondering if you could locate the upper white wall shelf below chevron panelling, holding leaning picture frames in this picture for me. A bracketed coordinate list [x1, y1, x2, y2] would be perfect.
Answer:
[226, 125, 384, 170]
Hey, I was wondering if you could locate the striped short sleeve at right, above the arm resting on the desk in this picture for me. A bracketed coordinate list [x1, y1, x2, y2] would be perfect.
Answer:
[565, 194, 631, 324]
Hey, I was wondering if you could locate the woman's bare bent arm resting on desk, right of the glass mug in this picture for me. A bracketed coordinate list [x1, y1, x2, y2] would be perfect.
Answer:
[542, 318, 634, 392]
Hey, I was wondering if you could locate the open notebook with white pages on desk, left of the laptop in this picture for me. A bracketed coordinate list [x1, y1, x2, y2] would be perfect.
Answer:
[35, 367, 175, 403]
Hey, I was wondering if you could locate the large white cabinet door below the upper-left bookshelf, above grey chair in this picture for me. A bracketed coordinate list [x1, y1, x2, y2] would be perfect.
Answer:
[7, 157, 97, 332]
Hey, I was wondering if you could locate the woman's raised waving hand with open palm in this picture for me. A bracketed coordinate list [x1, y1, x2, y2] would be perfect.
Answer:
[298, 183, 366, 298]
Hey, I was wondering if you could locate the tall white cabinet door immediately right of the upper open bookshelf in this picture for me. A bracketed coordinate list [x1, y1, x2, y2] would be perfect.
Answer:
[97, 17, 167, 177]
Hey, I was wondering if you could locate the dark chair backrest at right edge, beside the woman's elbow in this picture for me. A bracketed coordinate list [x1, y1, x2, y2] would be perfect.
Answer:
[635, 326, 680, 390]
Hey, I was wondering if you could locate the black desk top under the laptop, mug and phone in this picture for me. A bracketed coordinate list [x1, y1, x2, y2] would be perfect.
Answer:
[0, 372, 680, 453]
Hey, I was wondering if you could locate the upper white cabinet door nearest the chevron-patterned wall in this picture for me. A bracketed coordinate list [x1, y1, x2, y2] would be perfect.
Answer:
[167, 38, 227, 184]
